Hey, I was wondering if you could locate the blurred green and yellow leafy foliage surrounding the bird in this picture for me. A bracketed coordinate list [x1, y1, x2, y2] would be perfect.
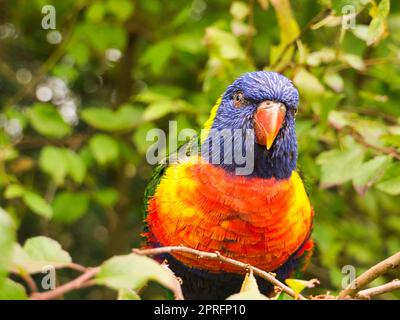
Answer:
[0, 0, 400, 299]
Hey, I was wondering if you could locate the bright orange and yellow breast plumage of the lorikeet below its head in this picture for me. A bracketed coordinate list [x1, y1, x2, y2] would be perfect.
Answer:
[147, 158, 313, 272]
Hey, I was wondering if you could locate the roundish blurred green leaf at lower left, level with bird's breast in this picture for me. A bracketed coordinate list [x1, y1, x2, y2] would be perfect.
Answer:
[53, 192, 89, 223]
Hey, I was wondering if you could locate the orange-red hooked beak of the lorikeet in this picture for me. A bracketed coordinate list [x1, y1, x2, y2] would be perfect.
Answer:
[254, 100, 286, 150]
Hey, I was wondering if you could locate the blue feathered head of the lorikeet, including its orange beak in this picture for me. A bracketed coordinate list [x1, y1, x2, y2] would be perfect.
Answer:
[202, 71, 299, 179]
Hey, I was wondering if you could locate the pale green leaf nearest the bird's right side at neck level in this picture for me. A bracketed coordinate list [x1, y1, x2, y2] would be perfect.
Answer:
[317, 146, 364, 188]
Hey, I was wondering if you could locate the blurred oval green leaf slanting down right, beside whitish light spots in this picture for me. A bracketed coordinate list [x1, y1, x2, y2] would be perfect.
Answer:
[27, 103, 71, 138]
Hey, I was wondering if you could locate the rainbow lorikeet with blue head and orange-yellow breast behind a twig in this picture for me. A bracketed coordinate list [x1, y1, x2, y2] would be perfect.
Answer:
[145, 71, 313, 299]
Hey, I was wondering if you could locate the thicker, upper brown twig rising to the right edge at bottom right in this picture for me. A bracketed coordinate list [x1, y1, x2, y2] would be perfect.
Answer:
[338, 251, 400, 299]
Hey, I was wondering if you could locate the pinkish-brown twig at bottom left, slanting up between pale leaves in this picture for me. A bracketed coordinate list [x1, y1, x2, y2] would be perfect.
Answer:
[30, 267, 100, 300]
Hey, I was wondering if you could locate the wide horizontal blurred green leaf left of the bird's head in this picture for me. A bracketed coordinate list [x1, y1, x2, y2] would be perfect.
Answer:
[81, 105, 142, 132]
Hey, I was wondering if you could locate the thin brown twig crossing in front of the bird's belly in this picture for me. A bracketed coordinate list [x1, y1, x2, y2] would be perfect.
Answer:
[133, 246, 306, 300]
